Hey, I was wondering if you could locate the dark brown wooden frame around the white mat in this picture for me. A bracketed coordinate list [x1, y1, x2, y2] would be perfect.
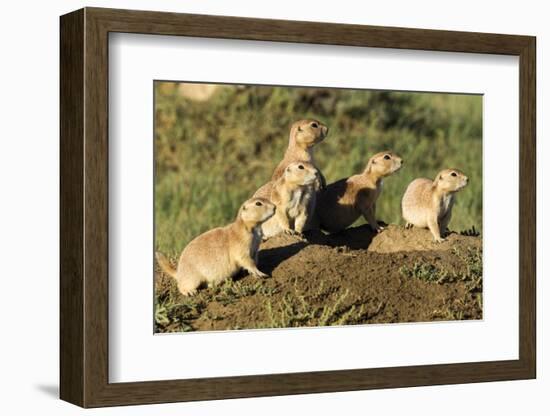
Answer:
[60, 8, 536, 407]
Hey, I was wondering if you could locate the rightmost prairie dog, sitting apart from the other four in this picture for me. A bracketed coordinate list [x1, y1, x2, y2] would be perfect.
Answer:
[401, 169, 468, 243]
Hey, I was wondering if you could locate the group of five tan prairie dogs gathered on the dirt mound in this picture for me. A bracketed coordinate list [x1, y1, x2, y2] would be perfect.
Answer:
[156, 119, 468, 295]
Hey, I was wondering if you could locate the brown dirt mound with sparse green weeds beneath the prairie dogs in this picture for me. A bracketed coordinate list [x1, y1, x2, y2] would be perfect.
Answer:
[155, 225, 482, 332]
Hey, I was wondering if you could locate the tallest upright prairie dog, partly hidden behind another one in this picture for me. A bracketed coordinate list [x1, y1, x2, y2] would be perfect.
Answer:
[271, 119, 328, 190]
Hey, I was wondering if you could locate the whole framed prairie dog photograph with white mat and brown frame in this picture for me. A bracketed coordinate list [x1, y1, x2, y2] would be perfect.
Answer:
[60, 8, 536, 407]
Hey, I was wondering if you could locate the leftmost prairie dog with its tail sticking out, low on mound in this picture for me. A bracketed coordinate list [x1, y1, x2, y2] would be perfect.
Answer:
[156, 198, 275, 295]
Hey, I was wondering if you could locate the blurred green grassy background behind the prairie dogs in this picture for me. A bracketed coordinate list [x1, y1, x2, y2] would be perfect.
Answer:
[155, 82, 482, 256]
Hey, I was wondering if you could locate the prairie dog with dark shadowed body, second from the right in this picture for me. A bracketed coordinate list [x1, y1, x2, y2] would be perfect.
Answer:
[316, 151, 403, 233]
